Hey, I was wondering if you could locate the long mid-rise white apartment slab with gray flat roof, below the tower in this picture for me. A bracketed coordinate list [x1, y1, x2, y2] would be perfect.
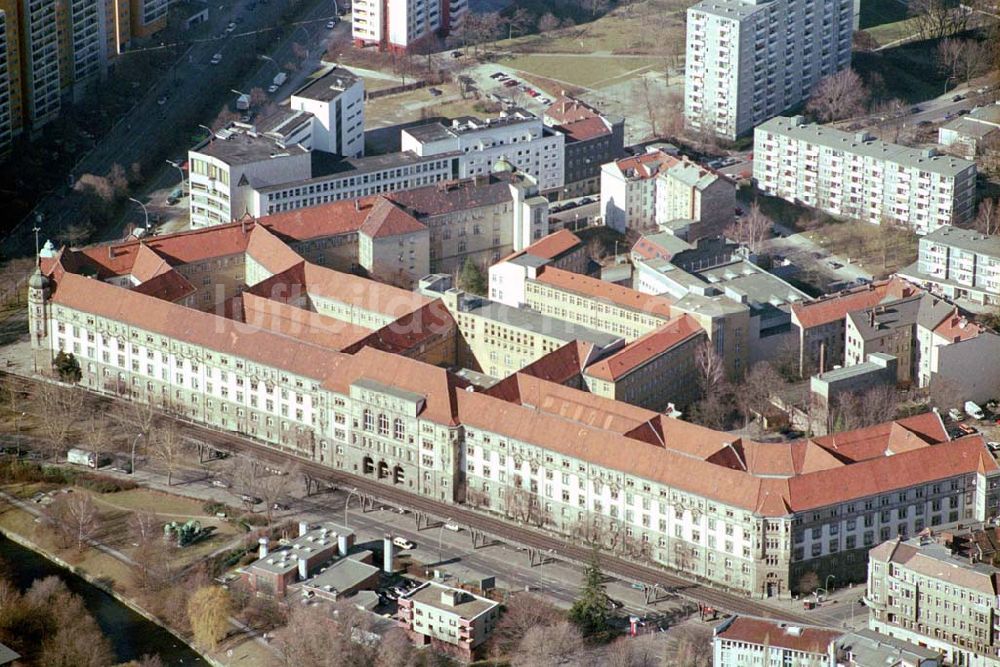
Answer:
[753, 116, 976, 234]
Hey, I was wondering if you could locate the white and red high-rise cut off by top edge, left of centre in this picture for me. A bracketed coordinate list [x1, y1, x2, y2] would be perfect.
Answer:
[352, 0, 469, 52]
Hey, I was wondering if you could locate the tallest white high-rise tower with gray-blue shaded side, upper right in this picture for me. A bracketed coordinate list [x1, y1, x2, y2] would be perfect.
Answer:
[684, 0, 856, 139]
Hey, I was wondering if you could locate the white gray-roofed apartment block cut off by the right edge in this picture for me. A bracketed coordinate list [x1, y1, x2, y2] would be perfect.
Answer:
[899, 227, 1000, 306]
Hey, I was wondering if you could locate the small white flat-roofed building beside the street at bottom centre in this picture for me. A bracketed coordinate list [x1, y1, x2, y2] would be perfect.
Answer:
[399, 581, 500, 659]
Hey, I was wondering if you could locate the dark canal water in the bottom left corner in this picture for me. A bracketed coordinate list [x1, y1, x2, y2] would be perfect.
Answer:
[0, 535, 208, 667]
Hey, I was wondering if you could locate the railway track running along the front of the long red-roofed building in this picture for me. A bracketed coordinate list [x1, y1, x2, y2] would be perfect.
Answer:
[0, 371, 815, 625]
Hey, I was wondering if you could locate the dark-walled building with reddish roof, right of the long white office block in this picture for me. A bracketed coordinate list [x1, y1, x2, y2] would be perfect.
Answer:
[543, 95, 625, 198]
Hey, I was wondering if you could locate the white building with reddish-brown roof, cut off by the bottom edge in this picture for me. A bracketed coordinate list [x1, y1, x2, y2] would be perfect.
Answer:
[712, 616, 844, 667]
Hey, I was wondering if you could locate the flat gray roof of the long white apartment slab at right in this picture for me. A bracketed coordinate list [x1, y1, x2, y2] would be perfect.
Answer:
[754, 116, 975, 177]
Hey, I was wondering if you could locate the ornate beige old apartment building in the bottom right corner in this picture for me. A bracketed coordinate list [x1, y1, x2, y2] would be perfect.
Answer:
[865, 537, 1000, 667]
